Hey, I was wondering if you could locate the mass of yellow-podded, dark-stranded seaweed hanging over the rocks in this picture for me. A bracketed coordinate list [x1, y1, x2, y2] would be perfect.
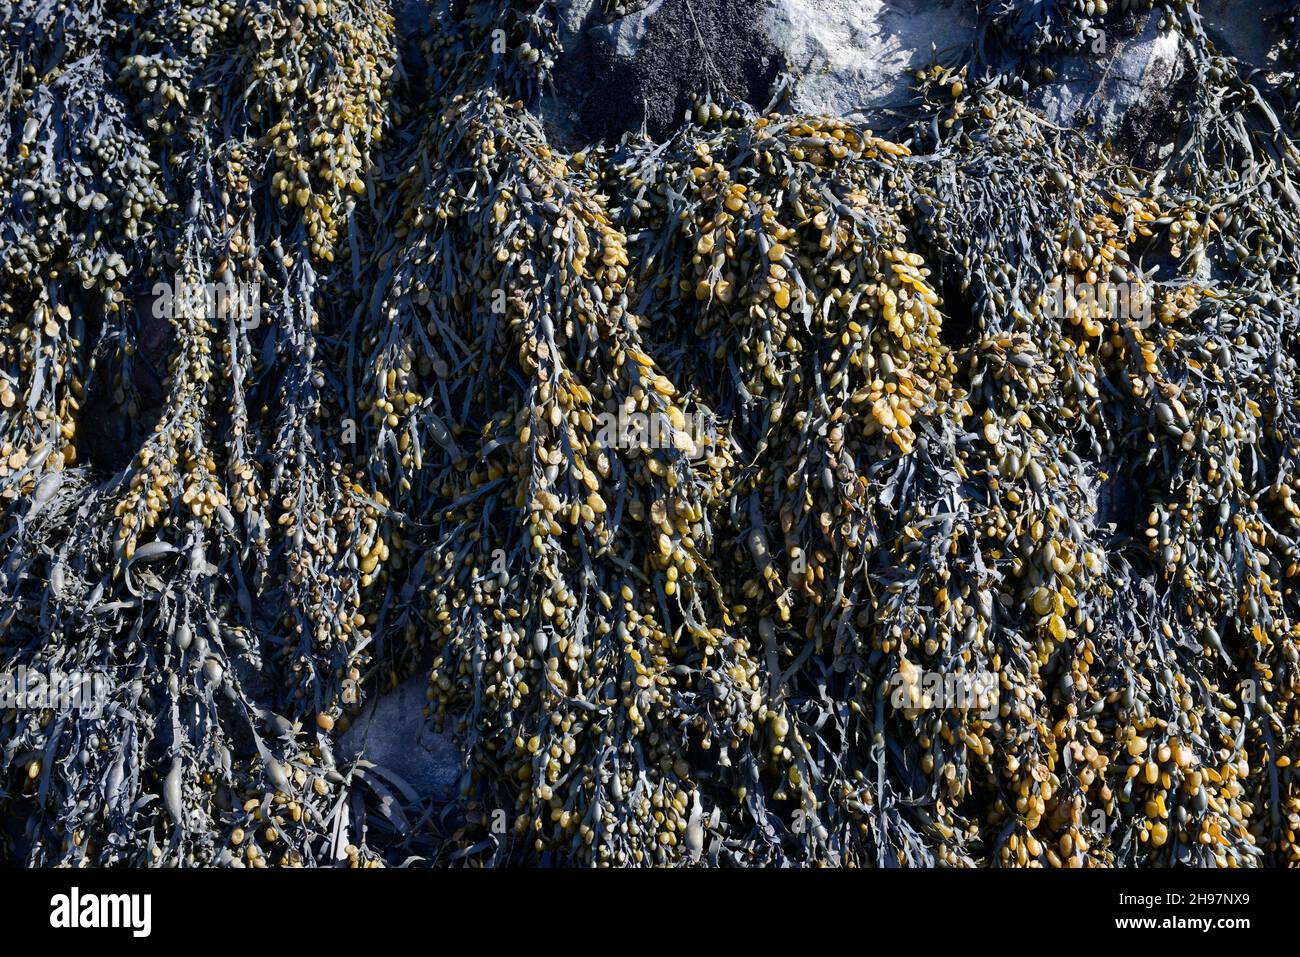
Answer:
[0, 0, 1300, 866]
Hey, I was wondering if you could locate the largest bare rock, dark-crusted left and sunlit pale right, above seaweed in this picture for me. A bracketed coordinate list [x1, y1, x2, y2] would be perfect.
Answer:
[546, 0, 975, 140]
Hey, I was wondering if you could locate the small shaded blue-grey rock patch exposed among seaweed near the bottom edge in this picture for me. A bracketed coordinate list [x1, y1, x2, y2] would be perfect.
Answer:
[339, 676, 462, 801]
